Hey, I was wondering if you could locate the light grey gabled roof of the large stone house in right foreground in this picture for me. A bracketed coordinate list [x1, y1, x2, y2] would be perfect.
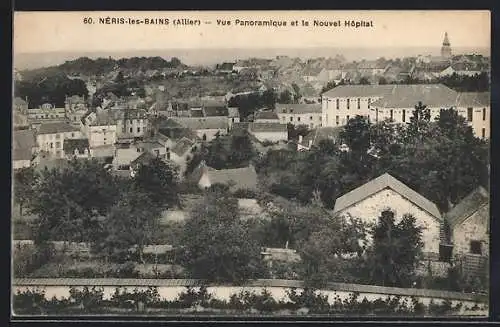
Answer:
[333, 173, 441, 221]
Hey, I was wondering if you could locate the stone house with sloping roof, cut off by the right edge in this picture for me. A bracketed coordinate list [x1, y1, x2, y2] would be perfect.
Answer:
[445, 187, 490, 256]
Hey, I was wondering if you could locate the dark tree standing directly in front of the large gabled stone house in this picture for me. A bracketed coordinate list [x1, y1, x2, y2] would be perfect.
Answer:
[368, 210, 423, 287]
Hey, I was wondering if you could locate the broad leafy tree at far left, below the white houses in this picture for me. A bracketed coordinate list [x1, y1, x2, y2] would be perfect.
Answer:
[29, 159, 119, 243]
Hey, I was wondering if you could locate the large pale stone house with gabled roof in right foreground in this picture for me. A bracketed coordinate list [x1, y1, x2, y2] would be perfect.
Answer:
[333, 173, 443, 257]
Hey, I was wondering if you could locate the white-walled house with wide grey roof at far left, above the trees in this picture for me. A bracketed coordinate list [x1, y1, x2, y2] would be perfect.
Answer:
[36, 123, 84, 158]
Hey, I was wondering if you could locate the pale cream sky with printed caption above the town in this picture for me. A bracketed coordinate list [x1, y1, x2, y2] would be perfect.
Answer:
[13, 11, 491, 57]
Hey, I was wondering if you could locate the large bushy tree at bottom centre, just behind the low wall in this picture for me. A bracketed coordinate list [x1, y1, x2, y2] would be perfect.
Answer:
[182, 190, 263, 283]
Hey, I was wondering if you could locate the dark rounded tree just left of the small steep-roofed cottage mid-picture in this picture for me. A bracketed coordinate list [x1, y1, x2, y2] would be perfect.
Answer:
[133, 157, 179, 208]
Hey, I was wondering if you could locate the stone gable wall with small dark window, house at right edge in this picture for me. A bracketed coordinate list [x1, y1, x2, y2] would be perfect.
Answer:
[452, 204, 490, 256]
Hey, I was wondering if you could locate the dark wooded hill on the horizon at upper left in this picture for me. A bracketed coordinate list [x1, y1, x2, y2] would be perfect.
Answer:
[18, 57, 187, 79]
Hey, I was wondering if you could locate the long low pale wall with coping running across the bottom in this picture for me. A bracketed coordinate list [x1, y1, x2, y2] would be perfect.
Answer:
[12, 278, 488, 305]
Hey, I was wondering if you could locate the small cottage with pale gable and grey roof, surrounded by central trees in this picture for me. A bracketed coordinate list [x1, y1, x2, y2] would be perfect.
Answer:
[191, 162, 258, 191]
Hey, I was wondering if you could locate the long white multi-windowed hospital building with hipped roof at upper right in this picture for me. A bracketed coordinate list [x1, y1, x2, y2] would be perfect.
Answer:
[322, 84, 490, 138]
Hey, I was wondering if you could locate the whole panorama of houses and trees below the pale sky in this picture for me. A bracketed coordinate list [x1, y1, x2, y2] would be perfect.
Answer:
[12, 33, 491, 314]
